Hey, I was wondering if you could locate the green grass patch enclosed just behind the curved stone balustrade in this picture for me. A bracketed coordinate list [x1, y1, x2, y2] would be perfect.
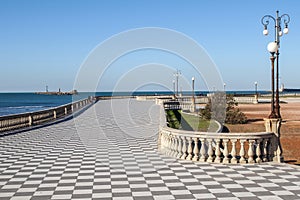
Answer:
[166, 110, 219, 132]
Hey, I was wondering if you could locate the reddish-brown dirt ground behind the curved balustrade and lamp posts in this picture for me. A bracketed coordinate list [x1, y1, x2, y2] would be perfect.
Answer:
[226, 98, 300, 164]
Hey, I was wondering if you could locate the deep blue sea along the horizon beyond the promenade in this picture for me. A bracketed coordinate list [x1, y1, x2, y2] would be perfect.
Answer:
[0, 91, 267, 116]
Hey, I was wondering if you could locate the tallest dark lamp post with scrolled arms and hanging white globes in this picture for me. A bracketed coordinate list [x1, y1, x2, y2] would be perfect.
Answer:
[261, 11, 290, 118]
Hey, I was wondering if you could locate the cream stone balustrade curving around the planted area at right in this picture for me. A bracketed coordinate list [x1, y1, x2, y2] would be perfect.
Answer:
[159, 127, 276, 163]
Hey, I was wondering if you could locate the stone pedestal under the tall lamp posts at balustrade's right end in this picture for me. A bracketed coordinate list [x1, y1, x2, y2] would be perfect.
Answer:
[264, 118, 284, 163]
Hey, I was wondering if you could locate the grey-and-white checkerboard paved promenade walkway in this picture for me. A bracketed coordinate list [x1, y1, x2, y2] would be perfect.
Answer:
[0, 99, 300, 200]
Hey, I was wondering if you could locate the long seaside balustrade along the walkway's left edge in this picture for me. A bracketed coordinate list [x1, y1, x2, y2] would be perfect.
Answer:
[0, 98, 94, 133]
